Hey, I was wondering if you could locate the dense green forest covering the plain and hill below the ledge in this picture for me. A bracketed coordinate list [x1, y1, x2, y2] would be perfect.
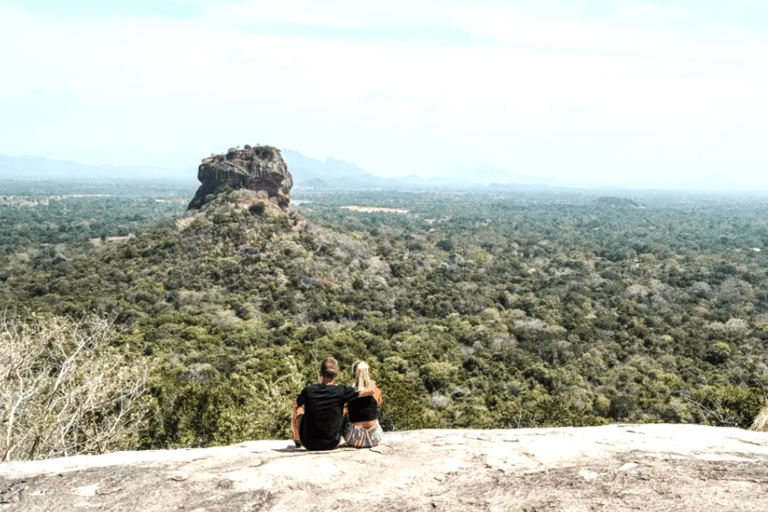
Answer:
[0, 180, 768, 458]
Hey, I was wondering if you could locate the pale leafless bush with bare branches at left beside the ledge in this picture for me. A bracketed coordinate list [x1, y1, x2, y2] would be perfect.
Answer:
[0, 318, 150, 461]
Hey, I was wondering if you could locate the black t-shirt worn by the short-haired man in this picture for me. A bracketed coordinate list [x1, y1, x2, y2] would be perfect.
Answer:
[296, 384, 360, 450]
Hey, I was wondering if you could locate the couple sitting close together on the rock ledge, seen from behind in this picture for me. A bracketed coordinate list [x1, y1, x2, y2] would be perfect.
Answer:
[291, 357, 382, 451]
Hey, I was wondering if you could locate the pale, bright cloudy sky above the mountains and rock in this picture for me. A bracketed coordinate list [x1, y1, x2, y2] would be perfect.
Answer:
[0, 0, 768, 184]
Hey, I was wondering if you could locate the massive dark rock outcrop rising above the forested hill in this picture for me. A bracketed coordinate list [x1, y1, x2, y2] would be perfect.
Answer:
[188, 146, 293, 210]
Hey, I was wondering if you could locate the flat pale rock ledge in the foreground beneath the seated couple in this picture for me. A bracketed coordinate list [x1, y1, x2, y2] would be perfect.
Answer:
[0, 425, 768, 512]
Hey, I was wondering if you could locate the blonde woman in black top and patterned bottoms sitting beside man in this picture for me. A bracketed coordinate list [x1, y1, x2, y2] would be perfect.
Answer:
[344, 361, 384, 448]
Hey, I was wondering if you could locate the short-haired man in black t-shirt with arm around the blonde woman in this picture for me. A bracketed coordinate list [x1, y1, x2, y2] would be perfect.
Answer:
[291, 357, 376, 451]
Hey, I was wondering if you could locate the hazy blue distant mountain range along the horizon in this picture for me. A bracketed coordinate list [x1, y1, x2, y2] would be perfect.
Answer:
[0, 149, 768, 191]
